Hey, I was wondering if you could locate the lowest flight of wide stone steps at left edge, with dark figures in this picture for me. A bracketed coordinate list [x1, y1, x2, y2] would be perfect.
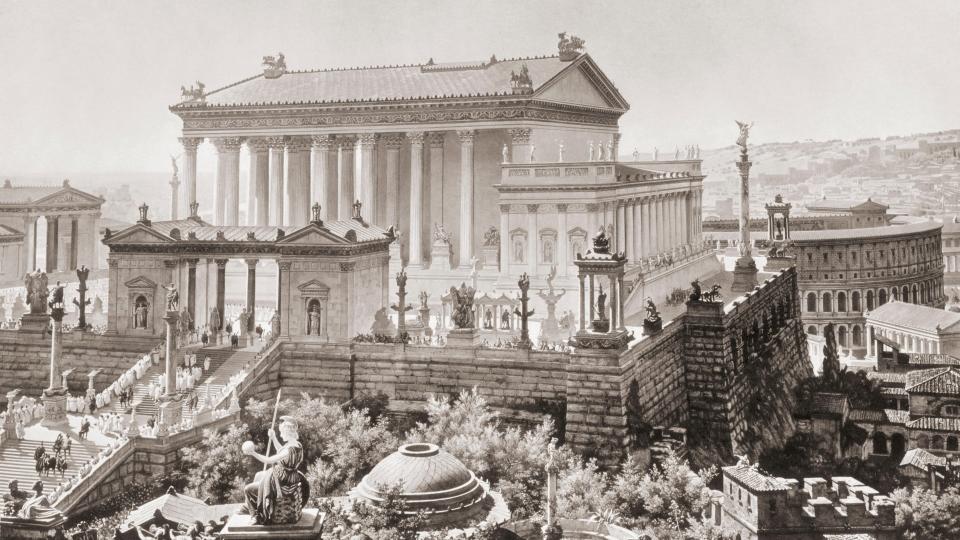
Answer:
[0, 437, 106, 493]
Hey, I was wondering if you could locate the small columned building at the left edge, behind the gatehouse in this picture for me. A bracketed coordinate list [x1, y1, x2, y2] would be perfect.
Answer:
[0, 180, 104, 281]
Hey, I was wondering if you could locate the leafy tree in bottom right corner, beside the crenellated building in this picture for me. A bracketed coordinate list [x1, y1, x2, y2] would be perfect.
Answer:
[893, 487, 960, 540]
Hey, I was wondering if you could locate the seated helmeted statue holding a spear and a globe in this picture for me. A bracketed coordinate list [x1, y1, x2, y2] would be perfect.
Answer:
[241, 392, 310, 525]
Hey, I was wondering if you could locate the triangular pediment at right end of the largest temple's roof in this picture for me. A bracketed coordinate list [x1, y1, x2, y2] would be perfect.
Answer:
[533, 54, 630, 111]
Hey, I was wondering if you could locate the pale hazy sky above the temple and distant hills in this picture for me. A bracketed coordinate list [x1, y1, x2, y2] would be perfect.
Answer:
[0, 0, 960, 176]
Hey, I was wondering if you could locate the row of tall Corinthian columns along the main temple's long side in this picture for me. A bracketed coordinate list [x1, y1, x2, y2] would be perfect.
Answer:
[180, 130, 476, 265]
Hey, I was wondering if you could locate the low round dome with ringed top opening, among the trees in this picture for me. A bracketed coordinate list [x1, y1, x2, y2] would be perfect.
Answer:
[350, 443, 510, 528]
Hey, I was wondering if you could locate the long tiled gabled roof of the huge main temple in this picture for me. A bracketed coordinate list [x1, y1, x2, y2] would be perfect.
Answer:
[173, 54, 629, 111]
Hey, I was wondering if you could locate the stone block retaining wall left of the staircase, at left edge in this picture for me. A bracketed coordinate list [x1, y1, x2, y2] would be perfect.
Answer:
[0, 330, 160, 408]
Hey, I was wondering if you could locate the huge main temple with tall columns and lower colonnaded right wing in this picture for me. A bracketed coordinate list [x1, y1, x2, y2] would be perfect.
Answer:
[171, 37, 718, 316]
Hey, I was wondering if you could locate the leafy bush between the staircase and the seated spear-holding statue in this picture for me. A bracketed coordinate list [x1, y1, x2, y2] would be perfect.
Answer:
[180, 424, 253, 504]
